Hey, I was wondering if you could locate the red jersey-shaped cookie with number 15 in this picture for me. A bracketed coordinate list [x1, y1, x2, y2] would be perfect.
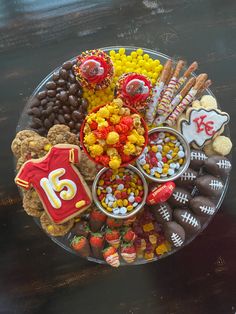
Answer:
[15, 144, 92, 224]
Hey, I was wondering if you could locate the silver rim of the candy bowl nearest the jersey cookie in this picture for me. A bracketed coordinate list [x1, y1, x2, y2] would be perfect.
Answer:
[92, 165, 148, 219]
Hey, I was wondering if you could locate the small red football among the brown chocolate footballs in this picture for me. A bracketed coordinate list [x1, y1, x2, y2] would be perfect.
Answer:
[147, 181, 175, 205]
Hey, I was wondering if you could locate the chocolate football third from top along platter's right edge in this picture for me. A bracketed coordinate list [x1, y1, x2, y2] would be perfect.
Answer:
[189, 196, 216, 216]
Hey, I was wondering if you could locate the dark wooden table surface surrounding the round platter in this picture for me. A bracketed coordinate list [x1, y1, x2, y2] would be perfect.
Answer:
[0, 0, 236, 314]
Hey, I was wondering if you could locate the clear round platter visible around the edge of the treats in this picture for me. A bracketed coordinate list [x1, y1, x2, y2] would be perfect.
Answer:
[16, 46, 231, 266]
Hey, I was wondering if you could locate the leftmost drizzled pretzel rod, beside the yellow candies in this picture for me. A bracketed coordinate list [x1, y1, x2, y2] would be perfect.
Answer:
[146, 59, 172, 124]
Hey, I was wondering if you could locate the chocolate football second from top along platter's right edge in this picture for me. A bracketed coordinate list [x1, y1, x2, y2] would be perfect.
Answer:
[196, 175, 224, 197]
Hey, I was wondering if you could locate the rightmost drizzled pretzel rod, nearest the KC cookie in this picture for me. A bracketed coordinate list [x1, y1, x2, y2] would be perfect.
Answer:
[166, 73, 207, 126]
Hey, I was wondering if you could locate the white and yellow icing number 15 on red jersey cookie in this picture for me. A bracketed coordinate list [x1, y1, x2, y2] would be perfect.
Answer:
[40, 168, 77, 208]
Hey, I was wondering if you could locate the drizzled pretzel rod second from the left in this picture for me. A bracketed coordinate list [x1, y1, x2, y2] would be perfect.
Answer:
[157, 60, 184, 117]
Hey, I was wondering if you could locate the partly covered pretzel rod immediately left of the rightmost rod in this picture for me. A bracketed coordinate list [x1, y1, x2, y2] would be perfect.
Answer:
[153, 77, 196, 126]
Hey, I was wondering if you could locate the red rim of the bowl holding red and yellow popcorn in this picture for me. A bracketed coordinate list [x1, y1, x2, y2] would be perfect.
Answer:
[80, 104, 148, 168]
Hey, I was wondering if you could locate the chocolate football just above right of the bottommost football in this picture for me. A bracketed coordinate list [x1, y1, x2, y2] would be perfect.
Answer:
[174, 209, 201, 233]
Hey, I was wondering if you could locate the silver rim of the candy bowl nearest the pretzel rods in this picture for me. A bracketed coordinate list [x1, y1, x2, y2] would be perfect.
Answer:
[136, 127, 190, 183]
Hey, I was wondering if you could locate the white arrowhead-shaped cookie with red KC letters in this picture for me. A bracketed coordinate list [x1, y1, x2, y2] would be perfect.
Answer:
[179, 108, 229, 148]
